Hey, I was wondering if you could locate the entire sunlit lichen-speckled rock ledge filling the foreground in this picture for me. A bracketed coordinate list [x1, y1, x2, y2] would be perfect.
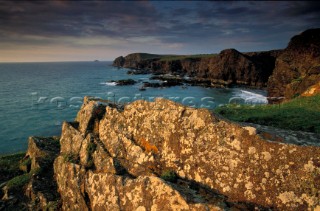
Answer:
[0, 97, 320, 211]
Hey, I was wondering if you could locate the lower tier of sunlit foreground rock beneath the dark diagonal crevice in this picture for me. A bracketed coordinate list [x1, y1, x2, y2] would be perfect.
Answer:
[54, 149, 227, 210]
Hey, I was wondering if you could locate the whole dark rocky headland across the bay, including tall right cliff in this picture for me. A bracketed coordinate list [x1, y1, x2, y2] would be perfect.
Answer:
[113, 29, 320, 103]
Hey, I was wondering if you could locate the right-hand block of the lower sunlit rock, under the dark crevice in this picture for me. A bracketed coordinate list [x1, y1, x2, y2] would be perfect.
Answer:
[86, 171, 222, 210]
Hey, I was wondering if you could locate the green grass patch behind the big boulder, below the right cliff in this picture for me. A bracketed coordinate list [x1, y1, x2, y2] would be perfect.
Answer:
[215, 95, 320, 134]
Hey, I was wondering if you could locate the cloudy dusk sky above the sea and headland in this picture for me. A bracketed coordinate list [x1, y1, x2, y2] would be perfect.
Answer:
[0, 0, 320, 62]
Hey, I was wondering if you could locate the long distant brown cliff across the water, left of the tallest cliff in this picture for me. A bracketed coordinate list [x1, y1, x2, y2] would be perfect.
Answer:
[113, 49, 281, 87]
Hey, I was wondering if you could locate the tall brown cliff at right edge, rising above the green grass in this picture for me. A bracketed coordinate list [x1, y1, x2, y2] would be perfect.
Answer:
[268, 29, 320, 103]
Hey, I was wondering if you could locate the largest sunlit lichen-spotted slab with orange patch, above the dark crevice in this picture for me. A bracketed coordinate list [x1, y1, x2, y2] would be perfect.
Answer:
[99, 100, 320, 210]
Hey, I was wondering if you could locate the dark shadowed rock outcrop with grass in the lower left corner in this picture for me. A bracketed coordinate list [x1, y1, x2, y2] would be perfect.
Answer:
[0, 137, 61, 210]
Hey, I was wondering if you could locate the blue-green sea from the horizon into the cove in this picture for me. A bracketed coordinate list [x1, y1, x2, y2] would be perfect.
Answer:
[0, 62, 266, 155]
